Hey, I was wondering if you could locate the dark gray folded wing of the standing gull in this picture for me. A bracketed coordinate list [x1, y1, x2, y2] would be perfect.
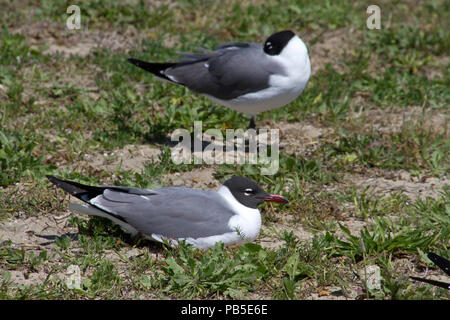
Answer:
[164, 42, 282, 100]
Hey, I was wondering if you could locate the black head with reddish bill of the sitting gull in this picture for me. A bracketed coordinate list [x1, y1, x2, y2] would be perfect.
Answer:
[223, 176, 288, 209]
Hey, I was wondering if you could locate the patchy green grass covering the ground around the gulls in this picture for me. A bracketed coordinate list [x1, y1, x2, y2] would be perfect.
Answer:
[0, 0, 450, 300]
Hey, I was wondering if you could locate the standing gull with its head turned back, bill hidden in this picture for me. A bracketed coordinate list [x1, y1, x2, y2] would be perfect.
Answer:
[128, 30, 311, 128]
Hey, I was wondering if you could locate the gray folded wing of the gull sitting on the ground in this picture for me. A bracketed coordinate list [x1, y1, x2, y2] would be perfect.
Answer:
[90, 187, 233, 239]
